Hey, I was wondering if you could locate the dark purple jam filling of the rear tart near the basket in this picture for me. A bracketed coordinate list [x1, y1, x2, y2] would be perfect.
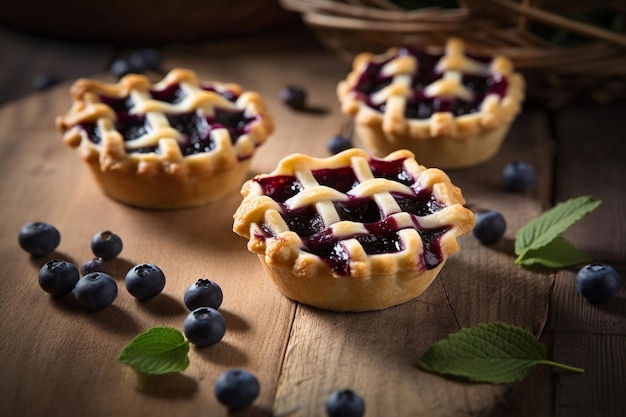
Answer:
[354, 48, 508, 119]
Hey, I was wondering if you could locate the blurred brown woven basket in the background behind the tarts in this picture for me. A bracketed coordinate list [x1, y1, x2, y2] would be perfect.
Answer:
[280, 0, 626, 103]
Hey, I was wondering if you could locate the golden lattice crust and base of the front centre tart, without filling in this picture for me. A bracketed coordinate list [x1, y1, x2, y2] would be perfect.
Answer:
[233, 149, 475, 311]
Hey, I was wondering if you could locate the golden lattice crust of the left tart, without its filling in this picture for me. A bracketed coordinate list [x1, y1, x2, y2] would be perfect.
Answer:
[56, 68, 274, 209]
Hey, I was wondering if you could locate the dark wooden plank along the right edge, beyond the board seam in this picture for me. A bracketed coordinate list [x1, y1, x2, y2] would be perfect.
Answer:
[547, 103, 626, 417]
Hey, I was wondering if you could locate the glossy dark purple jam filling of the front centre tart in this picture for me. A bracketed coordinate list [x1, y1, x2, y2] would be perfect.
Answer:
[254, 159, 450, 275]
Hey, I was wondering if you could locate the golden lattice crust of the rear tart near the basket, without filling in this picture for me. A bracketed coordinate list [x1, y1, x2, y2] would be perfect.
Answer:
[337, 38, 525, 168]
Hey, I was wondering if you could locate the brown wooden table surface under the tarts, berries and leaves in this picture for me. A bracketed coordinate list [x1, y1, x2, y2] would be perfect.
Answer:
[0, 22, 626, 417]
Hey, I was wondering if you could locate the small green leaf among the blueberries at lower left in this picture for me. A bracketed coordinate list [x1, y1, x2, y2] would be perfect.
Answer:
[117, 327, 189, 375]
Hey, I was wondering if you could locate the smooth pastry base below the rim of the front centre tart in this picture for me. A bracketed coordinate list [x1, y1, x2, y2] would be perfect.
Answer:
[259, 254, 446, 312]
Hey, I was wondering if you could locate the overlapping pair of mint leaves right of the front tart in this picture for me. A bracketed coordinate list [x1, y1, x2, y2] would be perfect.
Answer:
[515, 196, 601, 266]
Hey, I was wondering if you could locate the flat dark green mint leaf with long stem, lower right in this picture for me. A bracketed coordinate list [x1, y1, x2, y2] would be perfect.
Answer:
[417, 323, 584, 384]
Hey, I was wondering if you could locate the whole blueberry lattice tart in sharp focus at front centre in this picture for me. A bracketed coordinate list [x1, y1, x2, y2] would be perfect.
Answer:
[233, 148, 475, 311]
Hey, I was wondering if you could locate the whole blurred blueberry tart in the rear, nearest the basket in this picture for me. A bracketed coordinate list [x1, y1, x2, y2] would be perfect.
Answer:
[337, 38, 525, 169]
